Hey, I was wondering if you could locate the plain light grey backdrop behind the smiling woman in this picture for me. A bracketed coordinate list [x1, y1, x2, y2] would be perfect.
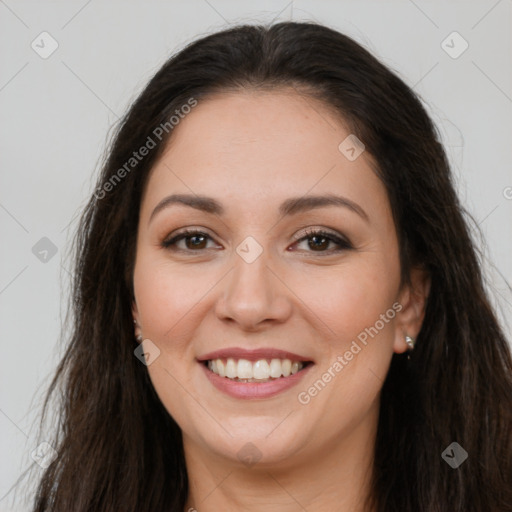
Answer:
[0, 0, 512, 511]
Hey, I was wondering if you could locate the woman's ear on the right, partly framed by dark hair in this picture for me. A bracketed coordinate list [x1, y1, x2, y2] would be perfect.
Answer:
[393, 267, 431, 354]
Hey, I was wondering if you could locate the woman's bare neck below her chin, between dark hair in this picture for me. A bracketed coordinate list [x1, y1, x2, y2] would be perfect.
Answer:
[184, 406, 377, 512]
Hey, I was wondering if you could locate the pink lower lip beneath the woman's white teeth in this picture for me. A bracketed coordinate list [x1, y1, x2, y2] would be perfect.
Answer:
[199, 363, 313, 399]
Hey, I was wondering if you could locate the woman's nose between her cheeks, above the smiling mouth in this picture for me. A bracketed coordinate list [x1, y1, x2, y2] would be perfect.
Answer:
[215, 251, 293, 331]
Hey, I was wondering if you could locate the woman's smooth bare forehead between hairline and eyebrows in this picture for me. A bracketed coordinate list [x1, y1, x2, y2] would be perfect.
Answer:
[140, 90, 386, 220]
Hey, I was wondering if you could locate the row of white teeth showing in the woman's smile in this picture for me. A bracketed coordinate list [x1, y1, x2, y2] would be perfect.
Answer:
[208, 357, 304, 382]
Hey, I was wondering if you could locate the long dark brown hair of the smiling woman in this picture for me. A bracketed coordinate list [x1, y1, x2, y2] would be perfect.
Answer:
[27, 22, 512, 512]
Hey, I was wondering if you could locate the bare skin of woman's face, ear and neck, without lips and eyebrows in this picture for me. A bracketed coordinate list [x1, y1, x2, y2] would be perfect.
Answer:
[133, 89, 429, 512]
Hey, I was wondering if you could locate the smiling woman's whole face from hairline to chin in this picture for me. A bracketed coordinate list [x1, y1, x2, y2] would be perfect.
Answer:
[133, 90, 416, 466]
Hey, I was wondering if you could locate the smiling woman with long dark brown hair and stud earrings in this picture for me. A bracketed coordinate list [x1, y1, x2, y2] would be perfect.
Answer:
[34, 23, 512, 512]
